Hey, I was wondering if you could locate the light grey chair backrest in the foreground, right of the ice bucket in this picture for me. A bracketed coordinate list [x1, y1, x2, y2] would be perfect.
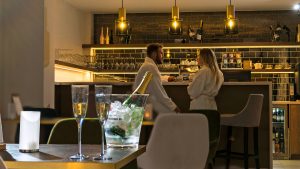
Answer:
[138, 113, 209, 169]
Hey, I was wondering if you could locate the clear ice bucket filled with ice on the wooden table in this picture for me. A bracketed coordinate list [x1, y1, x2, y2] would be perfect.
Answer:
[105, 94, 149, 147]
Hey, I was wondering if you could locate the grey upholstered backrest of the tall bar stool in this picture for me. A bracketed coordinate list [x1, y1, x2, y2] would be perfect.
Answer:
[238, 94, 264, 127]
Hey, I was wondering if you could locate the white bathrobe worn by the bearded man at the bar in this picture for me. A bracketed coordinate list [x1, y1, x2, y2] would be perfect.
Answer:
[133, 57, 177, 114]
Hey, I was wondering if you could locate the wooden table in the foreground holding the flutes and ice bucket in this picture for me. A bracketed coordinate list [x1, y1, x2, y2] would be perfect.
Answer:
[0, 144, 146, 169]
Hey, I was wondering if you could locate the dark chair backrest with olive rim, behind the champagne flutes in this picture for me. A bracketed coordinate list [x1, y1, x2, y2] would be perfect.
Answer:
[48, 118, 101, 144]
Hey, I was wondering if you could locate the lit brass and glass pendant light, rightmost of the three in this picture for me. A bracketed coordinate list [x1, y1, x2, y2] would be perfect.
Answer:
[224, 0, 238, 34]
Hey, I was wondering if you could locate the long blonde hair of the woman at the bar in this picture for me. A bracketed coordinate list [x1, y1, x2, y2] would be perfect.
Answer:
[200, 49, 220, 83]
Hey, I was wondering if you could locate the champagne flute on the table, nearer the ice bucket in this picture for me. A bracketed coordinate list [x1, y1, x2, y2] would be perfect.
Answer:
[94, 85, 112, 160]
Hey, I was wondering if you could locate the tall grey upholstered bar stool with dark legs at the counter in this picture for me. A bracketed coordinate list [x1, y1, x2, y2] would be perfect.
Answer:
[221, 94, 264, 169]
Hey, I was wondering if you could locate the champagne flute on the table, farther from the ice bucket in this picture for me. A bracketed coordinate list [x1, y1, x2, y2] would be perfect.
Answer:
[70, 85, 89, 160]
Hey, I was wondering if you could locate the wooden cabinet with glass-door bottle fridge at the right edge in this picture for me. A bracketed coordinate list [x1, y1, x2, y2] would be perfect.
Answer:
[272, 101, 300, 160]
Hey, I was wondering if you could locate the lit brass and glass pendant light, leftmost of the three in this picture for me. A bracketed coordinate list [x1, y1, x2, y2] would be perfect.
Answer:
[115, 0, 130, 36]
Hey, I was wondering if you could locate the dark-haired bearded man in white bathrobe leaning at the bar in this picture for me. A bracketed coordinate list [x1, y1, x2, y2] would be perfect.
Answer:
[133, 44, 180, 114]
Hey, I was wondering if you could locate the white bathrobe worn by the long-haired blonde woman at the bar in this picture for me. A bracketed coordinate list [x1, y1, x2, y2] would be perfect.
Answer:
[187, 66, 224, 110]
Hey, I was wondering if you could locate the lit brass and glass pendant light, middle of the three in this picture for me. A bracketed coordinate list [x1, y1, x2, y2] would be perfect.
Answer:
[169, 0, 182, 35]
